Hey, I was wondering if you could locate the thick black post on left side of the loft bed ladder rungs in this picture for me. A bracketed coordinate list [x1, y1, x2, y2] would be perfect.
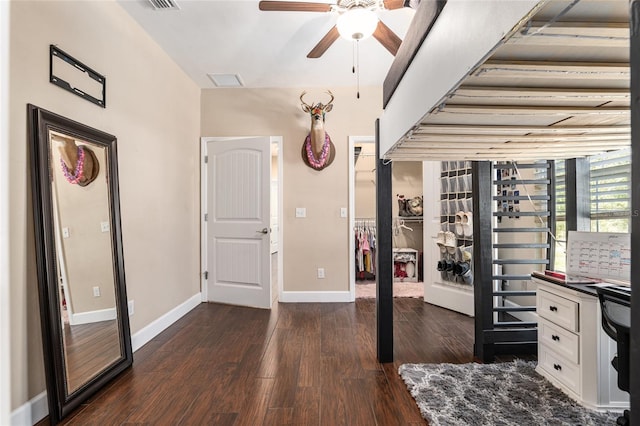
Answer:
[471, 161, 495, 362]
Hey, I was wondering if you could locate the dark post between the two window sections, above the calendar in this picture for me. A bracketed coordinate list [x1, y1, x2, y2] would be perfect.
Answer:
[565, 158, 591, 231]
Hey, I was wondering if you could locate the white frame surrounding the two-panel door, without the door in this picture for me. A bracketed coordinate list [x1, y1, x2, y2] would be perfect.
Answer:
[200, 136, 284, 303]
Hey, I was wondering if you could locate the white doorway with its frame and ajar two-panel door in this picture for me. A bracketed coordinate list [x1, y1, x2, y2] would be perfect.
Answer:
[201, 136, 283, 309]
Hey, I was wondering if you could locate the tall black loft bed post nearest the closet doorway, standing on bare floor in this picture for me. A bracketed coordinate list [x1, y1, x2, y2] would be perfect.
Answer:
[376, 120, 393, 363]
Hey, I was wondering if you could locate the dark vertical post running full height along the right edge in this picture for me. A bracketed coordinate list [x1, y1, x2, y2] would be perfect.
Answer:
[629, 0, 640, 418]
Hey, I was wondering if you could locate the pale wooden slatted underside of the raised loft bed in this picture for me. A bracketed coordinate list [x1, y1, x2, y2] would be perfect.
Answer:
[385, 0, 631, 161]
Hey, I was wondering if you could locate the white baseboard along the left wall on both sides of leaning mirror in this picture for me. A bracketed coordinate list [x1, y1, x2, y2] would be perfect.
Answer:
[11, 293, 202, 426]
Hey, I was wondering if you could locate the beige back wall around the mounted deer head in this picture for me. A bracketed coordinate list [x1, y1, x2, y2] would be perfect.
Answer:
[201, 87, 382, 291]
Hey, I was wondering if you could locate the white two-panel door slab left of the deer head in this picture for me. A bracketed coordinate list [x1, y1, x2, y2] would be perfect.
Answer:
[206, 137, 272, 308]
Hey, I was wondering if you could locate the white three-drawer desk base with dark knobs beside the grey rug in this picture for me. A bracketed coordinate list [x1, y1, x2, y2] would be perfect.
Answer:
[533, 278, 629, 410]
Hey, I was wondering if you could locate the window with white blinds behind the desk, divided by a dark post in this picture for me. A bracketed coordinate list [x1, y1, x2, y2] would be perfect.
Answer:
[554, 148, 631, 271]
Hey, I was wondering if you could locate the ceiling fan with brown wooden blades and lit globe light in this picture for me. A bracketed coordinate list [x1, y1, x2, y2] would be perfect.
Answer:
[259, 0, 410, 58]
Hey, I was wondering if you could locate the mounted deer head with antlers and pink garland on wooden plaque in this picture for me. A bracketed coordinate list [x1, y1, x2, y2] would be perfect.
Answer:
[300, 90, 335, 170]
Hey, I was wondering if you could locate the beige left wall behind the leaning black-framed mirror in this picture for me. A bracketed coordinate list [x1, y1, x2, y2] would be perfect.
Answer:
[9, 1, 200, 410]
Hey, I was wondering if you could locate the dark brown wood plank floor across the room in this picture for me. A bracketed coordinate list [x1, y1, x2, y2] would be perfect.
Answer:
[55, 299, 473, 426]
